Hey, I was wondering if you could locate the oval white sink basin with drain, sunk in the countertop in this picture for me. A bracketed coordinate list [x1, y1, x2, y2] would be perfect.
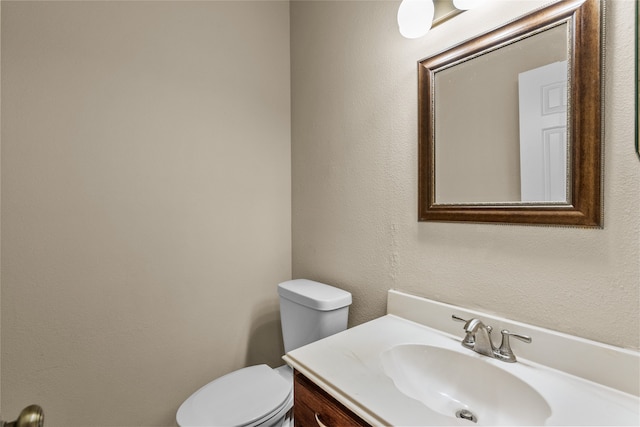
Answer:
[380, 344, 551, 425]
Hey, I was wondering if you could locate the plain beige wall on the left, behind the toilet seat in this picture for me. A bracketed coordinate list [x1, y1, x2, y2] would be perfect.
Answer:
[2, 1, 291, 427]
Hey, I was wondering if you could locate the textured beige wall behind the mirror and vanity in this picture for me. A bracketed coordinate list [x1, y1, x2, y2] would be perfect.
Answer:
[291, 1, 640, 349]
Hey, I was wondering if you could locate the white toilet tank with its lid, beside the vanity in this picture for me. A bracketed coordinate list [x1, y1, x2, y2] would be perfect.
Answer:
[278, 279, 351, 353]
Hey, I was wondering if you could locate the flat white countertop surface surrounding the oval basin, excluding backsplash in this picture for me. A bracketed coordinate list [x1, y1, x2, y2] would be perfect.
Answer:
[284, 290, 640, 426]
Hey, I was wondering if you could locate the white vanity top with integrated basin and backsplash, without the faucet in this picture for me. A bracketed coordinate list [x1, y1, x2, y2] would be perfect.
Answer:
[284, 300, 640, 427]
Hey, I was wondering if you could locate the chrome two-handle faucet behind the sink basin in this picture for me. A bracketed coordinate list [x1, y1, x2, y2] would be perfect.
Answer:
[451, 315, 531, 363]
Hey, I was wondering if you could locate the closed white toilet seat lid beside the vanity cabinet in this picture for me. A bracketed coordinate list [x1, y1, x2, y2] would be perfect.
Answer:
[176, 365, 293, 427]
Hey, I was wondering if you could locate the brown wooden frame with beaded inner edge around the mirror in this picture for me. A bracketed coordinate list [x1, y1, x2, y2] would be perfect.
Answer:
[418, 0, 604, 227]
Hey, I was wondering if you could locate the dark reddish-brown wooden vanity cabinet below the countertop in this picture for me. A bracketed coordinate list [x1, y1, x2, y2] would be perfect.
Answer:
[293, 371, 369, 427]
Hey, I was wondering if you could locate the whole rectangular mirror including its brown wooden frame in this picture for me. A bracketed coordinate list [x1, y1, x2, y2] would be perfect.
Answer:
[418, 0, 603, 227]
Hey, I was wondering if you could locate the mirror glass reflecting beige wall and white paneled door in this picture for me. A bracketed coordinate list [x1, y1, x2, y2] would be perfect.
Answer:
[434, 22, 570, 204]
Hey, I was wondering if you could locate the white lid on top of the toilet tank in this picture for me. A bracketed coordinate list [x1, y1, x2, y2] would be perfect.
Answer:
[278, 279, 351, 311]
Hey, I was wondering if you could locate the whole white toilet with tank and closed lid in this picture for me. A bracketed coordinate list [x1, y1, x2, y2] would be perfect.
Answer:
[176, 279, 351, 427]
